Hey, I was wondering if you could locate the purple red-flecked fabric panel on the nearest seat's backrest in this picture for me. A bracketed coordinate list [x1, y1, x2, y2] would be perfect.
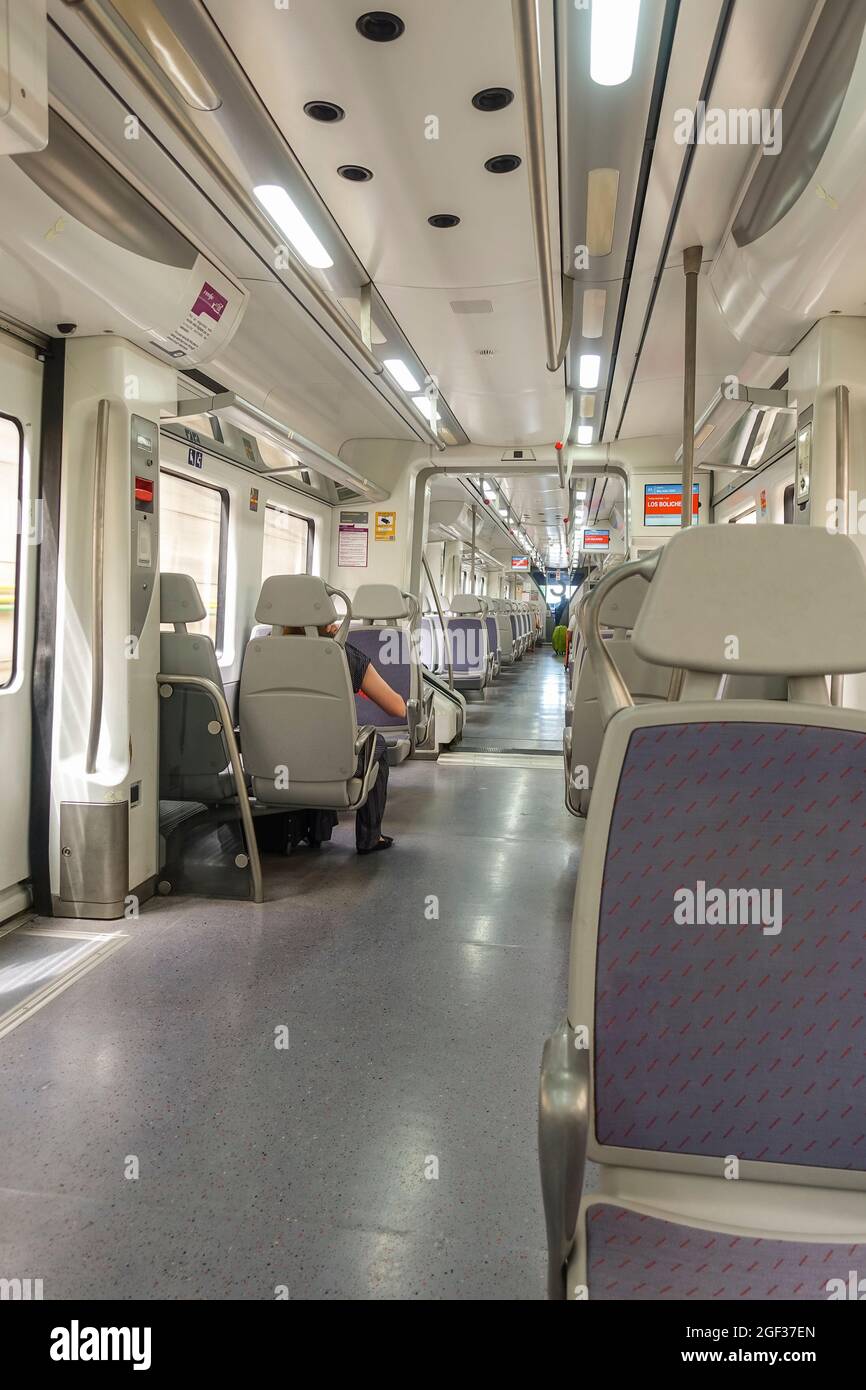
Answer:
[595, 723, 866, 1170]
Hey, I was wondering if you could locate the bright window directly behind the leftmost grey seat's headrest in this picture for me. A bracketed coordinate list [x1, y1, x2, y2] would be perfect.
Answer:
[160, 473, 228, 651]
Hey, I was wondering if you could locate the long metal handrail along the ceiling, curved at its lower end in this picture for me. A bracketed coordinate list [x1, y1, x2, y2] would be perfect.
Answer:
[512, 0, 571, 371]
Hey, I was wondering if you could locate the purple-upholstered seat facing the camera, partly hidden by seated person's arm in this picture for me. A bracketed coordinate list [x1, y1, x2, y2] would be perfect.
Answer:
[348, 584, 432, 766]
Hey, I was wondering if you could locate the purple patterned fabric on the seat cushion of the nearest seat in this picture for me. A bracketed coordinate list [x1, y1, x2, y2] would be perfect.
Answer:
[587, 1204, 866, 1301]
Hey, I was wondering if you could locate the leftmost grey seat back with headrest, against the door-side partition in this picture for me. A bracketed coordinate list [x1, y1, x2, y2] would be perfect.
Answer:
[160, 573, 234, 805]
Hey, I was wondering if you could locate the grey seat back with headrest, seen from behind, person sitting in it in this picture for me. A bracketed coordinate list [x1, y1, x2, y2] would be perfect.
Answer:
[240, 574, 378, 810]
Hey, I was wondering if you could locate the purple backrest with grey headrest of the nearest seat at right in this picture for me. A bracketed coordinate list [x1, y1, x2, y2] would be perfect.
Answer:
[569, 525, 866, 1190]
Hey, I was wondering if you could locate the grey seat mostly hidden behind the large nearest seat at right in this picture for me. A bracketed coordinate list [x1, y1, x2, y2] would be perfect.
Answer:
[563, 574, 673, 816]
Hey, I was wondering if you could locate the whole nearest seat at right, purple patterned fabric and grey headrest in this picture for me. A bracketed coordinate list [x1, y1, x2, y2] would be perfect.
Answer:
[539, 525, 866, 1300]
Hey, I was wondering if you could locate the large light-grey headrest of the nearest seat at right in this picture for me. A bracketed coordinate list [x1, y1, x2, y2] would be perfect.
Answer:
[632, 525, 866, 676]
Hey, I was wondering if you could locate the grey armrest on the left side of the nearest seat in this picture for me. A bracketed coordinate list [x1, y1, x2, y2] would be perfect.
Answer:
[538, 1019, 589, 1300]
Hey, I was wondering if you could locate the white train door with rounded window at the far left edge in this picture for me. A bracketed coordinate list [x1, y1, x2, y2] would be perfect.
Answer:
[0, 338, 43, 922]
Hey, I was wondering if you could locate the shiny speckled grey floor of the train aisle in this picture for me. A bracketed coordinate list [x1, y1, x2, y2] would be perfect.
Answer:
[0, 648, 578, 1298]
